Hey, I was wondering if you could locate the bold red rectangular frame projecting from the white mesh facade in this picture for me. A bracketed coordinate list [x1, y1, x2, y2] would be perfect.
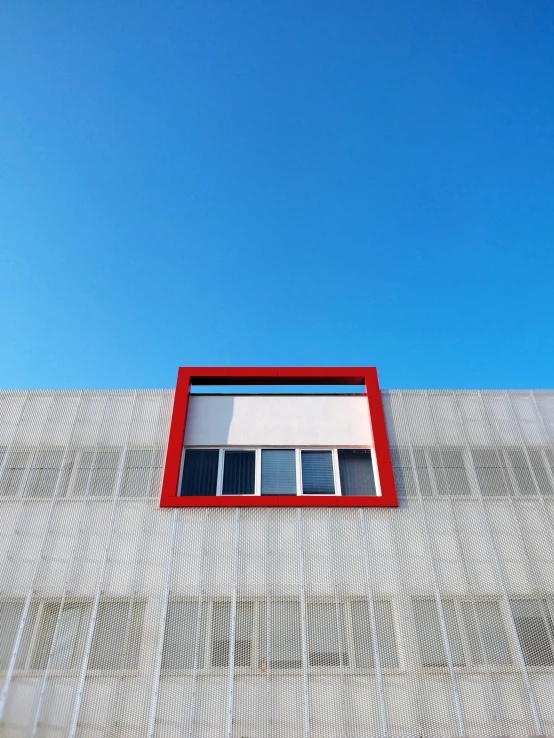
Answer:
[160, 366, 398, 507]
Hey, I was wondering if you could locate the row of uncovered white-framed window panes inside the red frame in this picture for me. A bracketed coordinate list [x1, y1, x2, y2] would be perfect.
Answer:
[179, 448, 377, 497]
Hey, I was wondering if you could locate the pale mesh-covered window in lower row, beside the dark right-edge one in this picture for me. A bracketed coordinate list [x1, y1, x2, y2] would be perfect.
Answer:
[414, 598, 512, 668]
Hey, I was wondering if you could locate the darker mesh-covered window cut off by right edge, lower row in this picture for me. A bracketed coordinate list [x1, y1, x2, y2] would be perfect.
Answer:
[511, 600, 554, 666]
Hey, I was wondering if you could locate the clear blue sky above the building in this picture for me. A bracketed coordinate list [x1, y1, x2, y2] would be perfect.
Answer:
[0, 0, 554, 388]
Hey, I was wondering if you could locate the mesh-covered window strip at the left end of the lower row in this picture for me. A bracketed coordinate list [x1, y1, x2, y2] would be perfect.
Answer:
[0, 598, 144, 671]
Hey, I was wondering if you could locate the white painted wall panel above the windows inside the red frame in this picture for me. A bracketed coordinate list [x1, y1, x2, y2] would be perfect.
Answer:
[185, 395, 373, 447]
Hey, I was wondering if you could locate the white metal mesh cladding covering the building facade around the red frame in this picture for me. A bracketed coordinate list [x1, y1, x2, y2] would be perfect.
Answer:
[0, 391, 554, 738]
